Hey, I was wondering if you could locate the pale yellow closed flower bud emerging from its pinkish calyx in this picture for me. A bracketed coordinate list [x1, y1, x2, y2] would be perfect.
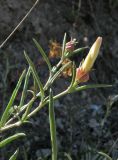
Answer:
[81, 37, 102, 73]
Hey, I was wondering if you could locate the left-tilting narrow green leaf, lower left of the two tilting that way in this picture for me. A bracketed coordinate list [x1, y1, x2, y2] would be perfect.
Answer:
[24, 52, 44, 98]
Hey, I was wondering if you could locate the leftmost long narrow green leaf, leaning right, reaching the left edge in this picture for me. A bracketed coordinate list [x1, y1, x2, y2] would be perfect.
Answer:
[0, 70, 26, 127]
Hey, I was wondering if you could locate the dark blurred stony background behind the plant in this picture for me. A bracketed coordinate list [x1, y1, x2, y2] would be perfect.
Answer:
[0, 0, 118, 160]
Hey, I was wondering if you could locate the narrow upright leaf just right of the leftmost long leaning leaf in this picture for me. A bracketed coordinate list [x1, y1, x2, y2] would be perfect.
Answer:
[19, 67, 31, 108]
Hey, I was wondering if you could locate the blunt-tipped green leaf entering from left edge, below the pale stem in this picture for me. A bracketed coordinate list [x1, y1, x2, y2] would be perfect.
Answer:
[0, 133, 26, 148]
